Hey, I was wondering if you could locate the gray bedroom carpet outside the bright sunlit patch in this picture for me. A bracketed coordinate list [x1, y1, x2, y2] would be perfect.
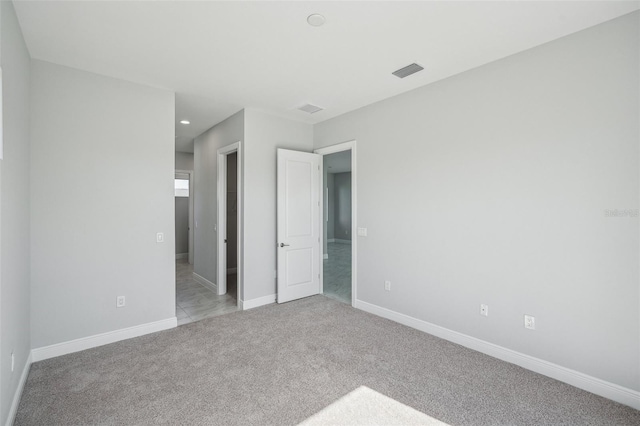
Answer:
[16, 296, 640, 425]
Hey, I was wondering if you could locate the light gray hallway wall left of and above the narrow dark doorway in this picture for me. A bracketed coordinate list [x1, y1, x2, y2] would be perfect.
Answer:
[193, 111, 245, 283]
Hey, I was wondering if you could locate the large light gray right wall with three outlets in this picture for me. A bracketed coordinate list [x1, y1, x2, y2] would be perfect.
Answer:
[314, 13, 640, 390]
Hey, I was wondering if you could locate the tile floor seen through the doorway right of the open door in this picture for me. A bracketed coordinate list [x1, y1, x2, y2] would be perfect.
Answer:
[323, 243, 351, 305]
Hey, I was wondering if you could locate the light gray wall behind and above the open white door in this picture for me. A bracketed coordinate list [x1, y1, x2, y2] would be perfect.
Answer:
[242, 109, 313, 300]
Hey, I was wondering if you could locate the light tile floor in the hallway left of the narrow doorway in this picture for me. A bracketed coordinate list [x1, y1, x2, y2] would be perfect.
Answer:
[176, 259, 238, 325]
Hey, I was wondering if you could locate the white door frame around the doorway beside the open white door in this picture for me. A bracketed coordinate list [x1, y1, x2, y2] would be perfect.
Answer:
[313, 139, 358, 307]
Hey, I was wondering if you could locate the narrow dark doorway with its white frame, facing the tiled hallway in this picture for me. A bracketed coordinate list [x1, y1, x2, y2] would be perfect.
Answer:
[216, 142, 243, 307]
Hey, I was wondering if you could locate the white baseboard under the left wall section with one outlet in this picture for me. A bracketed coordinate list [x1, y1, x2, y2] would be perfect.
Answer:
[31, 317, 178, 362]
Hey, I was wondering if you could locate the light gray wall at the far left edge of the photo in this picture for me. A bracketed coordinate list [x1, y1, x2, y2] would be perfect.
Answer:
[0, 1, 31, 424]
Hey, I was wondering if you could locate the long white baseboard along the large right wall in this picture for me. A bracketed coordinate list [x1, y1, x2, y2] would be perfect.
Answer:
[355, 299, 640, 410]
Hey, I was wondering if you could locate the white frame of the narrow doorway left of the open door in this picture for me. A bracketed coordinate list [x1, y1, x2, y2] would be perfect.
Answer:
[216, 141, 244, 309]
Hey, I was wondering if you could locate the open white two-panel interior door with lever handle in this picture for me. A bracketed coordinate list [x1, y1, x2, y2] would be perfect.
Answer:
[277, 149, 321, 303]
